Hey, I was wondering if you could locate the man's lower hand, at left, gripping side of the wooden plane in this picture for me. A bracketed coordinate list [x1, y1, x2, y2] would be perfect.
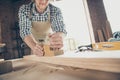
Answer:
[32, 43, 44, 57]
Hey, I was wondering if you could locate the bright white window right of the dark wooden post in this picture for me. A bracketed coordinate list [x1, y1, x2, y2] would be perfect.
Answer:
[103, 0, 120, 32]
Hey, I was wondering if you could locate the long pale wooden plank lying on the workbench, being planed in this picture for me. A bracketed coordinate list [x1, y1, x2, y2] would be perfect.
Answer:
[24, 55, 120, 73]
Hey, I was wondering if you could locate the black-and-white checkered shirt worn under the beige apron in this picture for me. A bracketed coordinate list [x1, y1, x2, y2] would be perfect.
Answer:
[18, 3, 67, 39]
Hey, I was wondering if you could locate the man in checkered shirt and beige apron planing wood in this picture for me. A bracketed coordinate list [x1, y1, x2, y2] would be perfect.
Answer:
[18, 0, 66, 56]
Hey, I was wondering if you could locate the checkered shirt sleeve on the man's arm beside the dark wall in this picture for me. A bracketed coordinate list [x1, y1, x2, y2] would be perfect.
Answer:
[18, 5, 31, 39]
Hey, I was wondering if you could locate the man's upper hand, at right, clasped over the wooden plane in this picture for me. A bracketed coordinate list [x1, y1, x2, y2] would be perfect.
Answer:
[49, 32, 63, 49]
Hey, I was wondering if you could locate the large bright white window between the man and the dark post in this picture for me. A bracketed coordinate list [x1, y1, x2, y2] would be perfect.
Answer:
[52, 0, 90, 50]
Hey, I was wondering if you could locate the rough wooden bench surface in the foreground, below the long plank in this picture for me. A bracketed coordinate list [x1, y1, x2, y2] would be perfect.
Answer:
[0, 59, 120, 80]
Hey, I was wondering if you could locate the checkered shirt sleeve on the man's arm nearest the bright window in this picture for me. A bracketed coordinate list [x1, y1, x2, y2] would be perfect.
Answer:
[51, 8, 67, 34]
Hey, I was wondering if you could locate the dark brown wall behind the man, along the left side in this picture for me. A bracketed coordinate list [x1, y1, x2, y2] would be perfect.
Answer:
[0, 0, 29, 59]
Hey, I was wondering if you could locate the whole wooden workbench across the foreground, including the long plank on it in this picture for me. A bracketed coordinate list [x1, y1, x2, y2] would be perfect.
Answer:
[0, 51, 120, 80]
